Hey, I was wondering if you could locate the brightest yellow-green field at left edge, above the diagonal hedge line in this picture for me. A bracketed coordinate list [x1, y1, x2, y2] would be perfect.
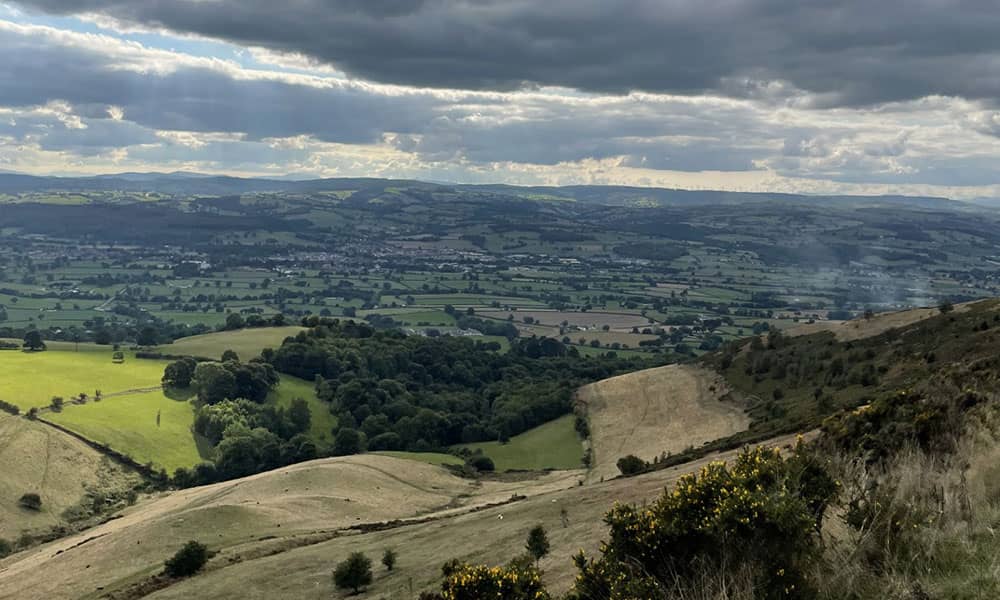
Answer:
[0, 344, 167, 411]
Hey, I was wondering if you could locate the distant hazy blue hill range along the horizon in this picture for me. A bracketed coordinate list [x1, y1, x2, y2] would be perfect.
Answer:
[0, 171, 984, 210]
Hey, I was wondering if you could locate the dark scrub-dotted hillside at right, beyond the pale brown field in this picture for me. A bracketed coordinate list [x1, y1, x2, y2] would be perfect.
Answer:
[705, 300, 1000, 436]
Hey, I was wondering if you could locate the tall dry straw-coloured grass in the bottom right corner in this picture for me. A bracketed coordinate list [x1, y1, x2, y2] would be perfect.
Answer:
[818, 436, 1000, 600]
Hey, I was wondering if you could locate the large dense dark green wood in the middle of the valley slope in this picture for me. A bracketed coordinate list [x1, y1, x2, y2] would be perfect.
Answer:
[264, 317, 646, 454]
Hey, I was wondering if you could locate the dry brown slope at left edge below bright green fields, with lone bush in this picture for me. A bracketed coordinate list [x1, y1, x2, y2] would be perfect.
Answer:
[0, 413, 140, 541]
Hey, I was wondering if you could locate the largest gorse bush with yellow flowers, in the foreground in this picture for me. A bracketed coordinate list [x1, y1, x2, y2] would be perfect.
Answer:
[572, 444, 837, 600]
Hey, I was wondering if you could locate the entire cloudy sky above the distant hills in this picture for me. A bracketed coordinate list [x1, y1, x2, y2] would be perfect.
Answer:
[0, 0, 1000, 199]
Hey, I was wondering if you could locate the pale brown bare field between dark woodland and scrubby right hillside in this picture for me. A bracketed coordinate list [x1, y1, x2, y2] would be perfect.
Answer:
[577, 365, 750, 481]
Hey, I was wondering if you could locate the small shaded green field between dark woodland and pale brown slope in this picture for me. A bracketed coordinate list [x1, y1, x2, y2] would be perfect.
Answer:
[464, 415, 583, 471]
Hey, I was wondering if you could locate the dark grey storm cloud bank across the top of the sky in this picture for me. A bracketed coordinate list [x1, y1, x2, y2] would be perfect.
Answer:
[15, 0, 1000, 106]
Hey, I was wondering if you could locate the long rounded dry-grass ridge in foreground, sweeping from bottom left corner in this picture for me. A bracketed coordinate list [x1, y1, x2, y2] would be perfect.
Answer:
[0, 455, 582, 598]
